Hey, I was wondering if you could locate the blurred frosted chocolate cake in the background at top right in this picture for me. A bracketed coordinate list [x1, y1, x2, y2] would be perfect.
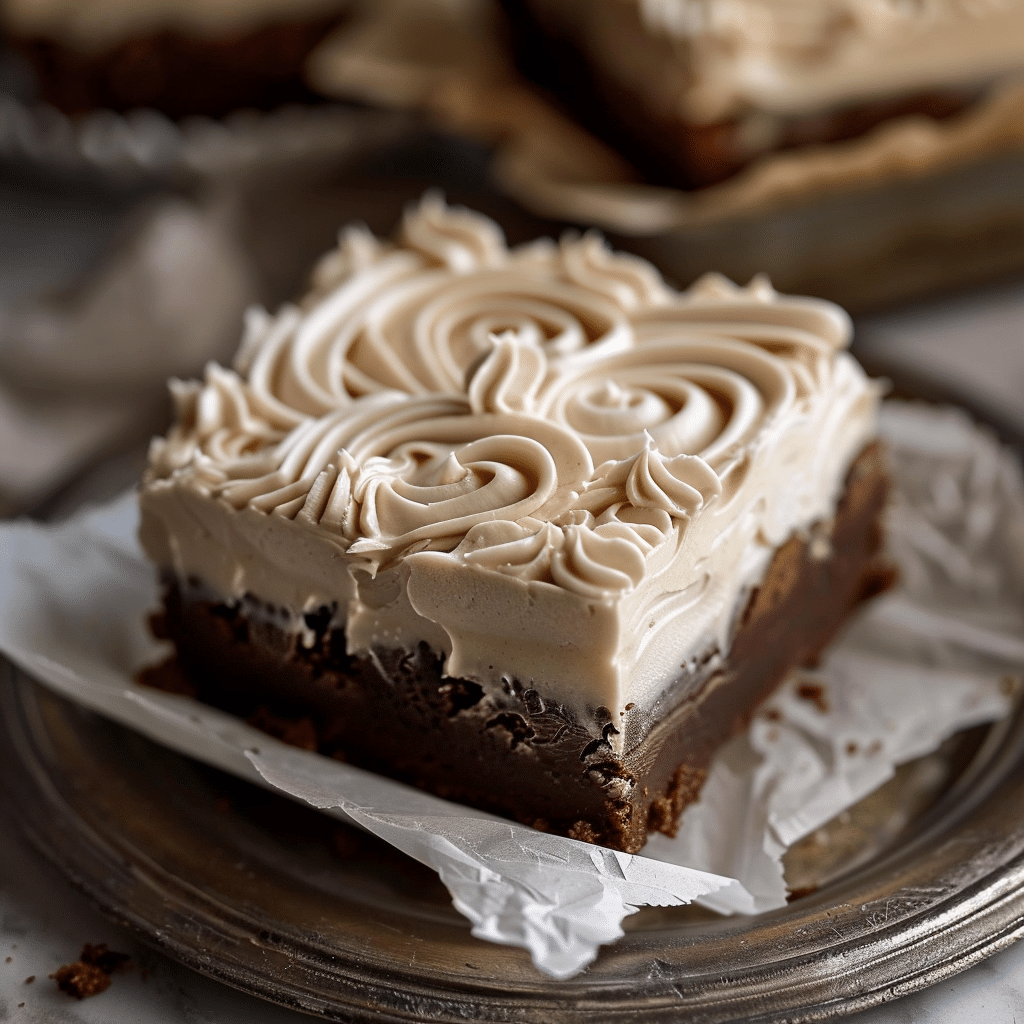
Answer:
[502, 0, 1024, 188]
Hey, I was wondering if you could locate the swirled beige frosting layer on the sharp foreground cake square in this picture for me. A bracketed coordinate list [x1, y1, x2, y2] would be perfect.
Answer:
[141, 196, 878, 729]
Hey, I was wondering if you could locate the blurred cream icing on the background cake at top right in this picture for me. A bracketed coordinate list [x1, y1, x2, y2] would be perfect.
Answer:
[531, 0, 1024, 123]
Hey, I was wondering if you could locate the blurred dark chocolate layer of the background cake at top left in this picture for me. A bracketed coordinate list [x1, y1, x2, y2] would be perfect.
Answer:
[4, 14, 348, 118]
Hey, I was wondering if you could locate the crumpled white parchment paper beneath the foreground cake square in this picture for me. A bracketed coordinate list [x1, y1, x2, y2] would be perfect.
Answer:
[0, 403, 1024, 978]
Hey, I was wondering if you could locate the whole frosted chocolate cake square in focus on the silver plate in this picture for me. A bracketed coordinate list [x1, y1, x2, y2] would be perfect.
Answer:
[140, 197, 888, 851]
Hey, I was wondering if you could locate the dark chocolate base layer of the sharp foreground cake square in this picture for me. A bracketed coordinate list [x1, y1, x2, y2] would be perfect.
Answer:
[143, 445, 892, 853]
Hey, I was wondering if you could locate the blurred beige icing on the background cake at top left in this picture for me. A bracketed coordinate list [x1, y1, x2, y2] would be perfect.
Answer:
[0, 0, 349, 50]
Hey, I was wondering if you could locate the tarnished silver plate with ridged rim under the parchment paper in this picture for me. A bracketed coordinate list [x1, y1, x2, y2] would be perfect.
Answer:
[6, 368, 1024, 1024]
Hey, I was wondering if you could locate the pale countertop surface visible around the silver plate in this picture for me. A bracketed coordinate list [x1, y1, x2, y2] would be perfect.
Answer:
[0, 163, 1024, 1024]
